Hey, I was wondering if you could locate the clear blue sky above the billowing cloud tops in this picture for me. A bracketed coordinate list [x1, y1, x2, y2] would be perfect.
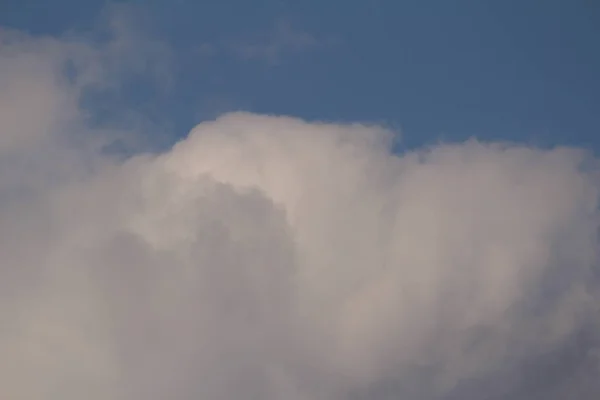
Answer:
[0, 0, 600, 151]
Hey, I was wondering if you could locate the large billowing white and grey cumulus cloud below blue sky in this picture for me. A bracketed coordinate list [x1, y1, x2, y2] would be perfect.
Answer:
[0, 13, 600, 400]
